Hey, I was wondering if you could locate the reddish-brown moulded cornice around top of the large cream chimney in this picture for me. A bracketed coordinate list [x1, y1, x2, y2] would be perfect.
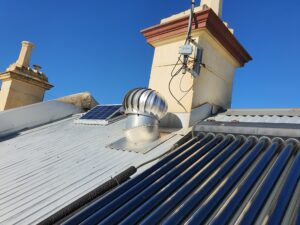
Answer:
[141, 9, 252, 66]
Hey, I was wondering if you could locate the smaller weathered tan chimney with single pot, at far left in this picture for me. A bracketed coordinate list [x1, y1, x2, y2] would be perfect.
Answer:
[0, 41, 53, 111]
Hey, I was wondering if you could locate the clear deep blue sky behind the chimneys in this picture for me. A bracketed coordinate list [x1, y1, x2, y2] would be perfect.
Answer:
[0, 0, 300, 108]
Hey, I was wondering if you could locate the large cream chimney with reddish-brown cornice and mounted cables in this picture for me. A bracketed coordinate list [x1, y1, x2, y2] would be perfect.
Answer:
[141, 0, 251, 127]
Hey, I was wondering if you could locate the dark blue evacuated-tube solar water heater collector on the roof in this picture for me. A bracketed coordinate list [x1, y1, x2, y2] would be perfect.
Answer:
[64, 134, 300, 225]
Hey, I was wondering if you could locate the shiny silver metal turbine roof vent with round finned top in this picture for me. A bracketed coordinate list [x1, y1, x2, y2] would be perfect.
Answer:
[123, 88, 168, 143]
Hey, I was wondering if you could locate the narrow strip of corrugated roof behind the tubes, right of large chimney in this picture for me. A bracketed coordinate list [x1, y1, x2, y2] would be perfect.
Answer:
[206, 109, 300, 124]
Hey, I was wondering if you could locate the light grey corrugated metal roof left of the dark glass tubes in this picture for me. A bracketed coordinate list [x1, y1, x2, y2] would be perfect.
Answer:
[0, 116, 181, 224]
